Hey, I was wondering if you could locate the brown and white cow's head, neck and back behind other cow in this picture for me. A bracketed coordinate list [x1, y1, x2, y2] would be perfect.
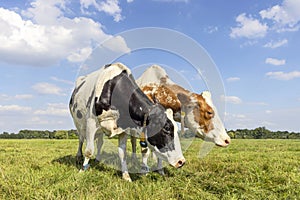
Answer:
[136, 65, 230, 147]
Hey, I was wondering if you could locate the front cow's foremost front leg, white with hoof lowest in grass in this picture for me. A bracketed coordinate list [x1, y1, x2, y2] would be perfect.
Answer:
[118, 133, 131, 182]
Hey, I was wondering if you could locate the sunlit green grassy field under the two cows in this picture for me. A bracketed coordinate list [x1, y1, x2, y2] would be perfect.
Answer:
[0, 140, 300, 200]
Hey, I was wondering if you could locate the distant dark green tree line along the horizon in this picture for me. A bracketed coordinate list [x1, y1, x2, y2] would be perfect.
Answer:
[0, 127, 300, 139]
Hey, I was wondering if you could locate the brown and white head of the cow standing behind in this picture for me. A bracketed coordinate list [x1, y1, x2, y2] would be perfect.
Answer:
[178, 91, 230, 147]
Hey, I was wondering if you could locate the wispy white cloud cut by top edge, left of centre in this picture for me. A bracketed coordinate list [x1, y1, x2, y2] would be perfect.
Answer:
[80, 0, 123, 22]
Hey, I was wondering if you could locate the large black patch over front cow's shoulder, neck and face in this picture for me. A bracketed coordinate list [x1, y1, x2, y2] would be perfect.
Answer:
[94, 70, 175, 151]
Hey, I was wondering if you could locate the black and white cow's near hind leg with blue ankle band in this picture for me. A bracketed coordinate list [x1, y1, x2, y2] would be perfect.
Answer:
[81, 118, 97, 171]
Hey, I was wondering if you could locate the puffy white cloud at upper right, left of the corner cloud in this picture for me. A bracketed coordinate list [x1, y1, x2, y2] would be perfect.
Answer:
[230, 13, 268, 39]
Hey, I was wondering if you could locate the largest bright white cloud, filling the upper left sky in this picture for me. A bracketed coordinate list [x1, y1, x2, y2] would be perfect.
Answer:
[0, 0, 128, 66]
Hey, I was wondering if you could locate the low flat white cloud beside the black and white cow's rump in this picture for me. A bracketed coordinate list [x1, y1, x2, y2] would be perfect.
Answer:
[34, 103, 70, 117]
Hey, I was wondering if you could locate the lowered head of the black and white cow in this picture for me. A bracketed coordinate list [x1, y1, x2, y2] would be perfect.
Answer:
[147, 104, 185, 168]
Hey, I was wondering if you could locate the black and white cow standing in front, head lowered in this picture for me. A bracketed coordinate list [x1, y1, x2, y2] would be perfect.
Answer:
[69, 63, 185, 181]
